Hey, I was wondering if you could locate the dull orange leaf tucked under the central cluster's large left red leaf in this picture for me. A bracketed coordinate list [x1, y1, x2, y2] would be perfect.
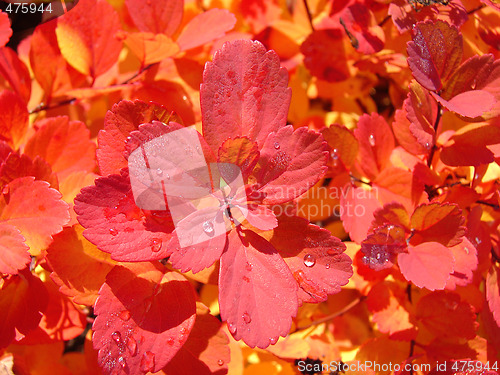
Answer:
[47, 225, 116, 306]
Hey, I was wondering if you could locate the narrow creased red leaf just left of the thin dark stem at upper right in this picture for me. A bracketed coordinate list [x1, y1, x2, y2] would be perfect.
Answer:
[404, 84, 438, 152]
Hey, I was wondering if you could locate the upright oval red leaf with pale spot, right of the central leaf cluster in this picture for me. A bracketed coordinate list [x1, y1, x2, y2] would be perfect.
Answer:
[354, 113, 394, 179]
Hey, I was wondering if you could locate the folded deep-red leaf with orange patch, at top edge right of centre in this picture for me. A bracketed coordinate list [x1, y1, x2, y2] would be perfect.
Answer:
[341, 3, 385, 54]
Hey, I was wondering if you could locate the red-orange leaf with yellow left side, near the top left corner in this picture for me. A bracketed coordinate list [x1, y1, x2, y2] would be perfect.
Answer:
[56, 0, 122, 79]
